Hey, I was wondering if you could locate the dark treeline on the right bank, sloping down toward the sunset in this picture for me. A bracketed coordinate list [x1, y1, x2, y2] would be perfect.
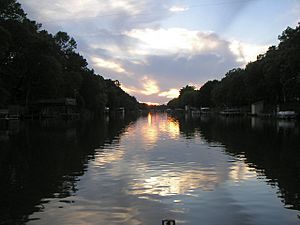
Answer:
[168, 24, 300, 108]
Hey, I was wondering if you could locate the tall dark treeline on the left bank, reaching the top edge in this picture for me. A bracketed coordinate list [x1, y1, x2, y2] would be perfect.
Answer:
[0, 0, 139, 112]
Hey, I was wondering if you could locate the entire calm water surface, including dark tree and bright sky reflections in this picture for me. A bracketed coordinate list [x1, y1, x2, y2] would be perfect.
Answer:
[0, 114, 300, 225]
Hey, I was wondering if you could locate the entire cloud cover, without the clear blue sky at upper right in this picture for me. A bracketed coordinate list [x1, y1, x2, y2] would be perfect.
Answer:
[20, 0, 272, 103]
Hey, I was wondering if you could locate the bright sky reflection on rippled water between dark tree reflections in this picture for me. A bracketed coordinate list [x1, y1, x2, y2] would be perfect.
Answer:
[22, 114, 297, 225]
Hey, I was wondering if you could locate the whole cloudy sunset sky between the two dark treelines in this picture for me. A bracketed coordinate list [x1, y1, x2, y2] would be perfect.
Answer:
[19, 0, 300, 104]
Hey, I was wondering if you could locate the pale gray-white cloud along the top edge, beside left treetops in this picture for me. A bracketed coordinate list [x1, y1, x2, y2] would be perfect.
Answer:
[20, 0, 170, 31]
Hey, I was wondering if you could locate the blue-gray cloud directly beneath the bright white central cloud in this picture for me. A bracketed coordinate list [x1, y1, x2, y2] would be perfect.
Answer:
[116, 31, 241, 89]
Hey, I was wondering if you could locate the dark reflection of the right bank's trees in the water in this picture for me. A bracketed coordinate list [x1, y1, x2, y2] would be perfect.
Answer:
[178, 117, 300, 210]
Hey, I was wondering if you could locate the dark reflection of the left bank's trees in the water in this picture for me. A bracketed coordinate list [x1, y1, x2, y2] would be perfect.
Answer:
[0, 118, 137, 225]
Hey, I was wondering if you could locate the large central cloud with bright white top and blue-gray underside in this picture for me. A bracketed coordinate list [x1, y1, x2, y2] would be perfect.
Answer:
[120, 29, 245, 81]
